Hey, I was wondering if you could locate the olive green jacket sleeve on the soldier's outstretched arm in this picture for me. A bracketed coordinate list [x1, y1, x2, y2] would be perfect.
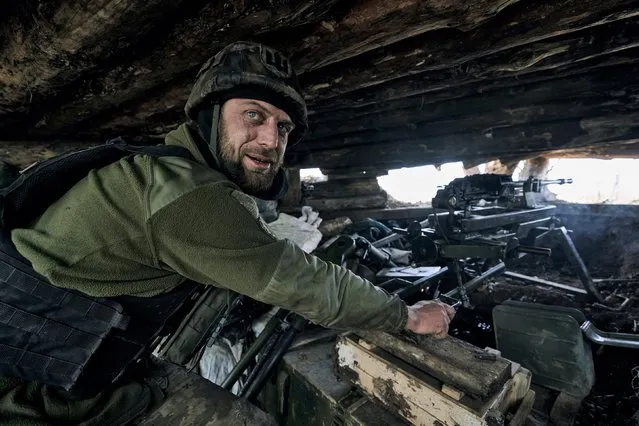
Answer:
[148, 182, 407, 331]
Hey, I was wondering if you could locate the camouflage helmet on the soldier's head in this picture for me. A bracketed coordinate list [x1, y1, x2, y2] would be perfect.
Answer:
[184, 42, 308, 145]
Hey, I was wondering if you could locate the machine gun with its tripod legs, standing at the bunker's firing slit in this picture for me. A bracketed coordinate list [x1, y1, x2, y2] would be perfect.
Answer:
[407, 174, 603, 305]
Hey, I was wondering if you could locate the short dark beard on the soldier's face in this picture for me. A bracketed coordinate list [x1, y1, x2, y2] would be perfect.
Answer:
[217, 121, 282, 195]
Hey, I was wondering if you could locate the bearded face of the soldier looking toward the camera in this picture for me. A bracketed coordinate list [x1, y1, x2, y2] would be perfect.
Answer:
[218, 98, 295, 194]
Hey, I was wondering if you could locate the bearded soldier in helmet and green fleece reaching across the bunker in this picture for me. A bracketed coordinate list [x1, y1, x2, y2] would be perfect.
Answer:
[0, 42, 454, 426]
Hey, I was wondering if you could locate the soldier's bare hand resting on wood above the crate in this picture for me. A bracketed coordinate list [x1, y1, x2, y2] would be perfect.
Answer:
[406, 300, 455, 338]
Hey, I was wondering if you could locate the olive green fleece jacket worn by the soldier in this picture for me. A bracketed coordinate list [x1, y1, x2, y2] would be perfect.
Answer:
[0, 125, 407, 421]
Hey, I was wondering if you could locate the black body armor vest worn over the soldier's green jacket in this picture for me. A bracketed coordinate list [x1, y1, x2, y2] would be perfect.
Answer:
[0, 138, 201, 398]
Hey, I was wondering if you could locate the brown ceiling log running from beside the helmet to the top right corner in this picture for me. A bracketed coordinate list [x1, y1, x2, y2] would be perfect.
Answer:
[302, 6, 637, 102]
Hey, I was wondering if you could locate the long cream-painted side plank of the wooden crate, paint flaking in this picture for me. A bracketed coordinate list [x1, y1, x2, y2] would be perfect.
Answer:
[337, 336, 530, 426]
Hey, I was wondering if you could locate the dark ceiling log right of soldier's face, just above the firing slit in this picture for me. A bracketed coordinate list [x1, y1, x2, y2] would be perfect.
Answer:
[299, 75, 639, 143]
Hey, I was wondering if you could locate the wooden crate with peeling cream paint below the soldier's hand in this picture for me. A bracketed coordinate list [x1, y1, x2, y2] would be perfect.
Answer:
[337, 334, 534, 426]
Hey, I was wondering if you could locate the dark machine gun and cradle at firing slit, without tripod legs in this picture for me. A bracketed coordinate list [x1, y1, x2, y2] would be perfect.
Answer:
[411, 174, 572, 262]
